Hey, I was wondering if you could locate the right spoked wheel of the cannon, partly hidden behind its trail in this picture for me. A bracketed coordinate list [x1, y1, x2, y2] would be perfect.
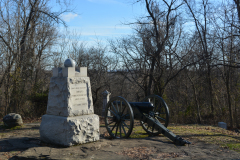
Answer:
[140, 95, 169, 136]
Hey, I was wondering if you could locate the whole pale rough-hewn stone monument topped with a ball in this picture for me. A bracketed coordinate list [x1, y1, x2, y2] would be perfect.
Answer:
[40, 59, 99, 146]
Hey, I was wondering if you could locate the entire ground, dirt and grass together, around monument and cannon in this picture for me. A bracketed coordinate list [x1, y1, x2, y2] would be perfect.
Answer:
[0, 118, 240, 160]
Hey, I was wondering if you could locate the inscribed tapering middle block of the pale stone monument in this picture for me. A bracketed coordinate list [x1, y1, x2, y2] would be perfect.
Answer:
[47, 77, 94, 117]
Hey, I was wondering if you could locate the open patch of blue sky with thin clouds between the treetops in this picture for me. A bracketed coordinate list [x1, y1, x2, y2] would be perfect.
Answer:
[57, 0, 145, 45]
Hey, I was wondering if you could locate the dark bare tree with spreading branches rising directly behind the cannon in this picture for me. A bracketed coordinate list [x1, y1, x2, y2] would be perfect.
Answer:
[110, 0, 198, 101]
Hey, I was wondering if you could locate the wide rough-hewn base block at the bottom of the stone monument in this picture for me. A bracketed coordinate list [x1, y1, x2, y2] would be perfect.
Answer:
[40, 114, 99, 146]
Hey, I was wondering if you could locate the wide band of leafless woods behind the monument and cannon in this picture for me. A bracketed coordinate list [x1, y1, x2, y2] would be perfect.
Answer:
[0, 0, 240, 128]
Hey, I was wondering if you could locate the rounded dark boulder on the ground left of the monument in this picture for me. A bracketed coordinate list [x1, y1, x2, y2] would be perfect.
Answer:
[3, 113, 23, 128]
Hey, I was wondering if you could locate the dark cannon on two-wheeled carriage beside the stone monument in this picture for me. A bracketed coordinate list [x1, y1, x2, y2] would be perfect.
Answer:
[104, 95, 191, 145]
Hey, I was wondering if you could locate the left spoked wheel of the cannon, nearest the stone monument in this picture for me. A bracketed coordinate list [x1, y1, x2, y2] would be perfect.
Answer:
[105, 97, 134, 138]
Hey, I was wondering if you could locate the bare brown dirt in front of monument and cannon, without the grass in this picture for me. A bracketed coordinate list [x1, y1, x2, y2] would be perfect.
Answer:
[0, 123, 240, 160]
